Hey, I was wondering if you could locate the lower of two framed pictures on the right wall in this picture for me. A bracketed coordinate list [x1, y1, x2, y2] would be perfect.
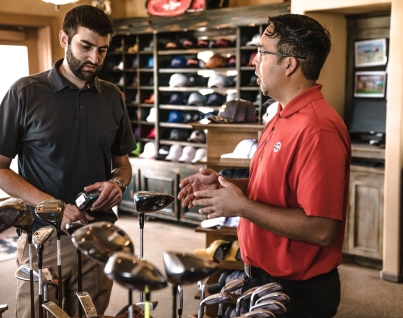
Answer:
[354, 71, 386, 97]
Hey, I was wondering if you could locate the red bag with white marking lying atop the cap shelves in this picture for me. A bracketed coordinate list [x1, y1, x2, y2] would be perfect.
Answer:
[146, 0, 229, 17]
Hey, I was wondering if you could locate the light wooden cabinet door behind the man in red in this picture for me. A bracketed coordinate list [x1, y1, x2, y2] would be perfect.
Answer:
[345, 167, 384, 259]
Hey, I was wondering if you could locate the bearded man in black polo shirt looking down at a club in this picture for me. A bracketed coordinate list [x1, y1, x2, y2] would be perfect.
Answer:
[0, 5, 136, 317]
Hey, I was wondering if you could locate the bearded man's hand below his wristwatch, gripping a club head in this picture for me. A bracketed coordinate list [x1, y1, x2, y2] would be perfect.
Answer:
[84, 180, 122, 211]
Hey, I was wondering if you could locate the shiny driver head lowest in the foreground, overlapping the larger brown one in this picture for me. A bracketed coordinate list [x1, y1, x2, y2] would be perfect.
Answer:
[104, 252, 167, 291]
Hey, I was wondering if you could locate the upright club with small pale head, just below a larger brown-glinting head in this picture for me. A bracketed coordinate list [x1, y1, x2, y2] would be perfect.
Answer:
[32, 226, 56, 318]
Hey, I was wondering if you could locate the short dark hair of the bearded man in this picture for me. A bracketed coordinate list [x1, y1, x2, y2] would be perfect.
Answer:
[62, 5, 115, 44]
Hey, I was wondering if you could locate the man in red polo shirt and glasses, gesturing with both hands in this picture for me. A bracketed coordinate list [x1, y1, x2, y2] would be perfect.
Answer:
[178, 14, 351, 318]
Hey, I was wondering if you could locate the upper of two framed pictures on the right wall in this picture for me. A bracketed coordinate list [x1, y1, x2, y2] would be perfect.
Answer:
[355, 39, 388, 67]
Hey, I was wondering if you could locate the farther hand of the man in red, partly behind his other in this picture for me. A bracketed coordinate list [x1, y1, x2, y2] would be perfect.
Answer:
[178, 168, 220, 209]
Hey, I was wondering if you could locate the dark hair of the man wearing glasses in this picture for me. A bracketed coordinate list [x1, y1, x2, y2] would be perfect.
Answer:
[264, 14, 331, 81]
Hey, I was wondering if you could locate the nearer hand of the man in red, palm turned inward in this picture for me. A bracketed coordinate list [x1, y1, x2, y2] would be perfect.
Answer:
[192, 176, 249, 219]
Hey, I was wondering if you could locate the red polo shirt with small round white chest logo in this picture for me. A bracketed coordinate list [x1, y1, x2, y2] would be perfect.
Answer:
[238, 85, 351, 280]
